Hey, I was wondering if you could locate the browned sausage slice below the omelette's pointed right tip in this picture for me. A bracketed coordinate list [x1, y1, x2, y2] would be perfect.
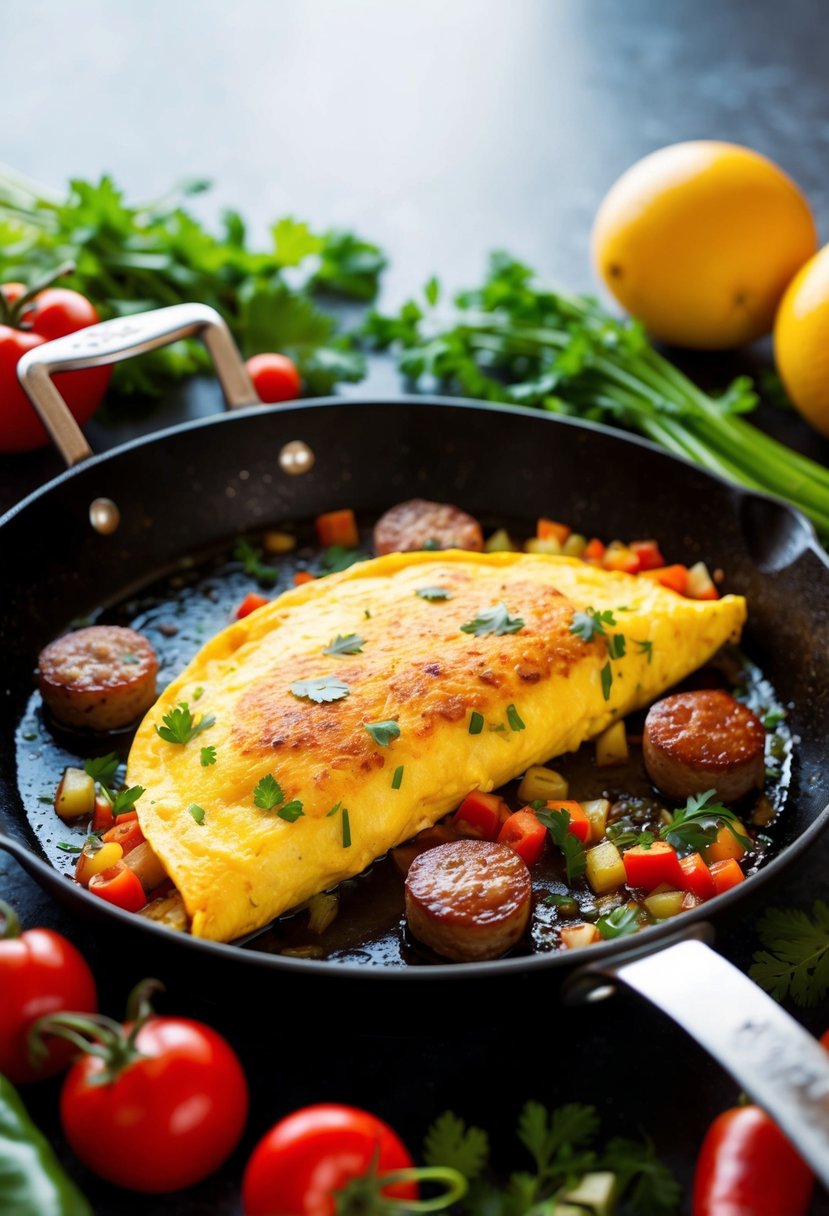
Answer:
[643, 688, 766, 803]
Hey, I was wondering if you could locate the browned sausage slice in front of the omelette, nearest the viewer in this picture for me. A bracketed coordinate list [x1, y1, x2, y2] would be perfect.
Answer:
[406, 840, 532, 963]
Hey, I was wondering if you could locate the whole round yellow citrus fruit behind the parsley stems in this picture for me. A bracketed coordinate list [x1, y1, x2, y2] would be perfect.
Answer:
[592, 140, 817, 350]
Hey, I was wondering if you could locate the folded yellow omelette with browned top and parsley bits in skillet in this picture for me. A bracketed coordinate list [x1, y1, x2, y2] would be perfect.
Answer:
[128, 551, 745, 941]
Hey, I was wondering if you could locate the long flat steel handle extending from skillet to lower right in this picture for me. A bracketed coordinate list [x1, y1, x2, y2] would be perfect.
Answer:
[570, 940, 829, 1187]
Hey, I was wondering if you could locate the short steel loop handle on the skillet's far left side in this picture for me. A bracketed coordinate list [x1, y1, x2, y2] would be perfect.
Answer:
[17, 304, 259, 467]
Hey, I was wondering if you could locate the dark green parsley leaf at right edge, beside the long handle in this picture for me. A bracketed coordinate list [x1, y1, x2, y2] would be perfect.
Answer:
[749, 900, 829, 1008]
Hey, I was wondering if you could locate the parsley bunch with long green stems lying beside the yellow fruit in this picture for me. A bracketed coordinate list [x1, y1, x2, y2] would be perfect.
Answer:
[365, 253, 829, 536]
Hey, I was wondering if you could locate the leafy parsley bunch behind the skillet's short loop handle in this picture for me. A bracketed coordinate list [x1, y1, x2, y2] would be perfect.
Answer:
[0, 170, 385, 396]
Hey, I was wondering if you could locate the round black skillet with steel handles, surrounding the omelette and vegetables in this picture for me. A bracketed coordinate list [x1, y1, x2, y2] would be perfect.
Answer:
[0, 305, 829, 1184]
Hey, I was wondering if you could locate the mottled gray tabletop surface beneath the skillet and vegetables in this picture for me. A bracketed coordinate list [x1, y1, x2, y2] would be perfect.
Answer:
[0, 0, 829, 1216]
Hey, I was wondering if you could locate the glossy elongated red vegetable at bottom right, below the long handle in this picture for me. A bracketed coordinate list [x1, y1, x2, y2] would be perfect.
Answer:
[692, 1107, 814, 1216]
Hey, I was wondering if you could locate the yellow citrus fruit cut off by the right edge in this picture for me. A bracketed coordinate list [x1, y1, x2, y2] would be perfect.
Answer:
[774, 244, 829, 435]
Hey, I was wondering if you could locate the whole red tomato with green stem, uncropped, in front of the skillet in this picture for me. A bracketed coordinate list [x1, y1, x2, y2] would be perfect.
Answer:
[61, 1017, 248, 1194]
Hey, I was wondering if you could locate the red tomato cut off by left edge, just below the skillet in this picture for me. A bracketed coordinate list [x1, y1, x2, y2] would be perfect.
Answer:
[0, 905, 97, 1085]
